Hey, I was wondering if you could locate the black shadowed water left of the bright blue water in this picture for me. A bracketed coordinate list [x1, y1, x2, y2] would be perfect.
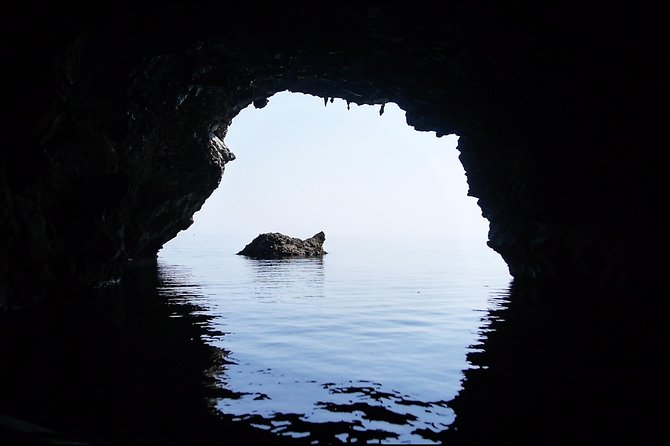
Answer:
[0, 264, 292, 444]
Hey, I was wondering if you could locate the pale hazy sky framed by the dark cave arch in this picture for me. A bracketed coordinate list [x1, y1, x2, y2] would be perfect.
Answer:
[181, 92, 488, 241]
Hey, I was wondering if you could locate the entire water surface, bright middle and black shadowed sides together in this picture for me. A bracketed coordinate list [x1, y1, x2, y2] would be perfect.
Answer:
[0, 235, 668, 444]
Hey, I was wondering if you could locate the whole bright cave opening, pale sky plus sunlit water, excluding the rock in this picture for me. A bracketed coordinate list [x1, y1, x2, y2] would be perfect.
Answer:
[158, 93, 510, 444]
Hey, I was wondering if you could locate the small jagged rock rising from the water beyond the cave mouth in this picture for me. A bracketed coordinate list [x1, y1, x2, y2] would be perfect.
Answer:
[237, 231, 327, 259]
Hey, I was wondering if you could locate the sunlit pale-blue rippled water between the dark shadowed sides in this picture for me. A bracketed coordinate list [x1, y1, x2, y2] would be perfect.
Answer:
[158, 233, 511, 443]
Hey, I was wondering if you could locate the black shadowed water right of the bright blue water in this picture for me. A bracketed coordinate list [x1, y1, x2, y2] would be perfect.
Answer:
[438, 283, 670, 445]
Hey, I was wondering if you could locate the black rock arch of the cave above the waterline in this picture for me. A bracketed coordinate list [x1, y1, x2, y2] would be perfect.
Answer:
[0, 2, 666, 301]
